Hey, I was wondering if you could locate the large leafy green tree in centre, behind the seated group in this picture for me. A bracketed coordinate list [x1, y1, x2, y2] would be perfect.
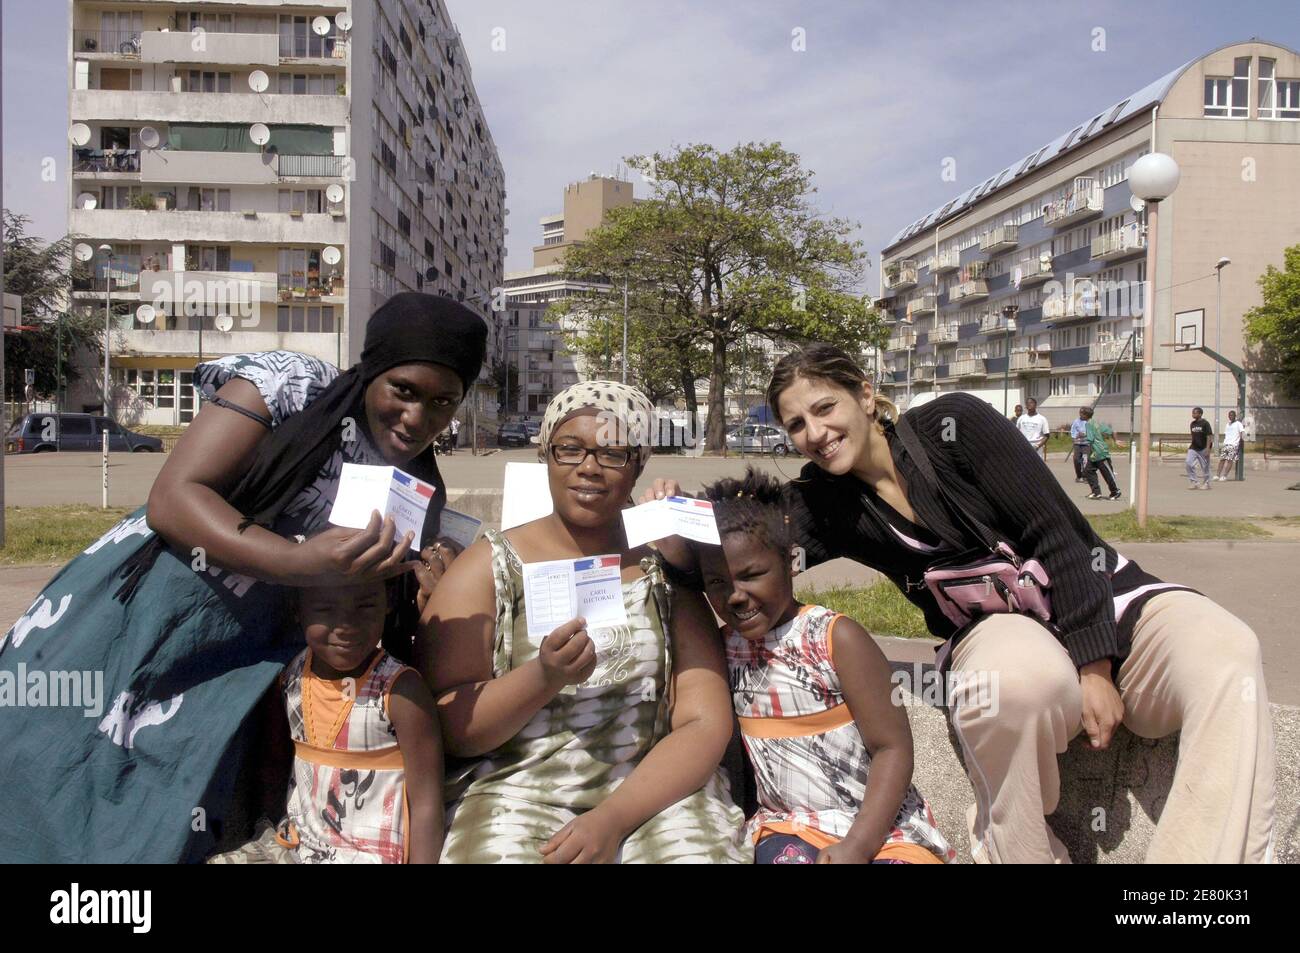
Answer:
[559, 143, 880, 450]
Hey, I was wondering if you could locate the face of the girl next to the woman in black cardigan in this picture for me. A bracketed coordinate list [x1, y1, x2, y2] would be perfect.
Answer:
[698, 532, 798, 640]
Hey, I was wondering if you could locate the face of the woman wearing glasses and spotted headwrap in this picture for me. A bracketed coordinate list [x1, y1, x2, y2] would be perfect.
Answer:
[545, 408, 641, 529]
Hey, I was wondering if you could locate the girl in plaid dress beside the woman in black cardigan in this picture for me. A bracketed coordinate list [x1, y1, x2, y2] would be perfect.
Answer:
[698, 468, 956, 863]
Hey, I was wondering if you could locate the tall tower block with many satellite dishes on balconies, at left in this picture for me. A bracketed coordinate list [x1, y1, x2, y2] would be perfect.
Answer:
[68, 0, 506, 424]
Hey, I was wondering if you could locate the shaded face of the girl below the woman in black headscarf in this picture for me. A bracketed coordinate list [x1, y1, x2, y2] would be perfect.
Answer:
[298, 582, 387, 677]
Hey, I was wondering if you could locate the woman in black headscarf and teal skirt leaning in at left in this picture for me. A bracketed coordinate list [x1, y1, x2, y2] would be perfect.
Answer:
[0, 293, 486, 862]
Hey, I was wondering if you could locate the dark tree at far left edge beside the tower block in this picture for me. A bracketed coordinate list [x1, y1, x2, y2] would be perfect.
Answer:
[3, 209, 104, 400]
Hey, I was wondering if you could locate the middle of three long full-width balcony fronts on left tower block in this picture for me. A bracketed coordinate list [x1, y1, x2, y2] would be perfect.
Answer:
[68, 208, 347, 247]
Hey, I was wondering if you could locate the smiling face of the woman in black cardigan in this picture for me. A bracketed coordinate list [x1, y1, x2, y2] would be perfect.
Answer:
[777, 377, 883, 476]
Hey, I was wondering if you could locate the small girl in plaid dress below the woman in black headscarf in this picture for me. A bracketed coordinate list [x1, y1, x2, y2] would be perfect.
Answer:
[280, 582, 443, 863]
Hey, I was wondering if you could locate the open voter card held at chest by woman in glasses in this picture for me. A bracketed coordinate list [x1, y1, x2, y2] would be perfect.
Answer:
[524, 554, 628, 637]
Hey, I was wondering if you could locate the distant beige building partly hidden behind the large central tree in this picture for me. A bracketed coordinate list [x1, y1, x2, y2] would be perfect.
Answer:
[498, 173, 633, 419]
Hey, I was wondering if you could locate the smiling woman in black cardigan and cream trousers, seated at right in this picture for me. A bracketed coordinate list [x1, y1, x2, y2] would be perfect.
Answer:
[650, 345, 1274, 863]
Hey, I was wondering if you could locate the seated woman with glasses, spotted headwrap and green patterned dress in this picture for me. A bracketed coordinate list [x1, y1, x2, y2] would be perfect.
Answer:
[416, 381, 750, 863]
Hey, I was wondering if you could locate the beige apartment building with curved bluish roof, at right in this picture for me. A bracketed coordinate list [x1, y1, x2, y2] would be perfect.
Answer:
[880, 40, 1300, 434]
